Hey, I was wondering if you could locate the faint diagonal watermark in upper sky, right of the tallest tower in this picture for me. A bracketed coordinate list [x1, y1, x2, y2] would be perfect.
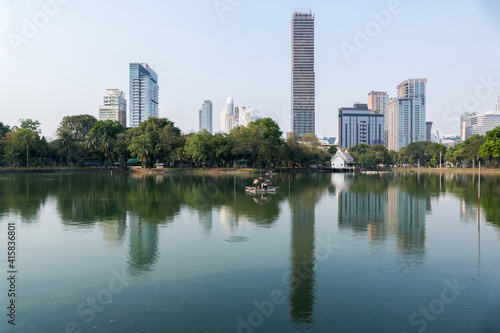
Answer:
[340, 0, 411, 63]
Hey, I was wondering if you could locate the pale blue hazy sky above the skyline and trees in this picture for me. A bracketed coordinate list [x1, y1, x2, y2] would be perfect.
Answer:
[0, 0, 500, 139]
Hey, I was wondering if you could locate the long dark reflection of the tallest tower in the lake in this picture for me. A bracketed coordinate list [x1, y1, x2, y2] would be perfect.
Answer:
[288, 174, 331, 328]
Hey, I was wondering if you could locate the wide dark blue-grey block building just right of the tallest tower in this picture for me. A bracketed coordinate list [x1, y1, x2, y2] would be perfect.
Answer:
[339, 104, 384, 149]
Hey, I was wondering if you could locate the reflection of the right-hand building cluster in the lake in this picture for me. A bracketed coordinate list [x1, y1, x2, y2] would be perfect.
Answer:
[332, 175, 431, 269]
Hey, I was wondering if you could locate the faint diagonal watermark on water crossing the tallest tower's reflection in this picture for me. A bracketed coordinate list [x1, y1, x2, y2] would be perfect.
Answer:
[236, 236, 340, 333]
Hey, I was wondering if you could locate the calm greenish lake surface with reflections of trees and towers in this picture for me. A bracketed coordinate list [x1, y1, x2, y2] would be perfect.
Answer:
[0, 173, 500, 333]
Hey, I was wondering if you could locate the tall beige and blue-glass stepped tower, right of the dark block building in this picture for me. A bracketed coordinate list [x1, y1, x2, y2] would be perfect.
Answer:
[387, 79, 427, 151]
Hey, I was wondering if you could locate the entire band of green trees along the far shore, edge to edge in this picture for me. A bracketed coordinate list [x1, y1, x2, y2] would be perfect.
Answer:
[0, 115, 500, 168]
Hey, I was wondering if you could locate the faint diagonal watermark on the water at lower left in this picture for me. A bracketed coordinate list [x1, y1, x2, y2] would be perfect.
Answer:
[64, 268, 130, 333]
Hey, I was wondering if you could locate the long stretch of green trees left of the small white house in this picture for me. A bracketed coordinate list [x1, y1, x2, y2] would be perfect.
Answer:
[0, 115, 332, 168]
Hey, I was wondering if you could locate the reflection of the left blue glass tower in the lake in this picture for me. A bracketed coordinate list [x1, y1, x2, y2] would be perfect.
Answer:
[128, 214, 158, 275]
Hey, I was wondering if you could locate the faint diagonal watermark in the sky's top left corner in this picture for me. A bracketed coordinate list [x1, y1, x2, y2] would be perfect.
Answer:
[7, 0, 71, 53]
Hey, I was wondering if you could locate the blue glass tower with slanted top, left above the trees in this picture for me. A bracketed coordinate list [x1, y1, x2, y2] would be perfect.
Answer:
[129, 63, 158, 127]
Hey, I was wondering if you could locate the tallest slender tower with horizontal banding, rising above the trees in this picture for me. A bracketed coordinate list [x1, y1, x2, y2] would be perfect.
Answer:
[292, 9, 316, 137]
